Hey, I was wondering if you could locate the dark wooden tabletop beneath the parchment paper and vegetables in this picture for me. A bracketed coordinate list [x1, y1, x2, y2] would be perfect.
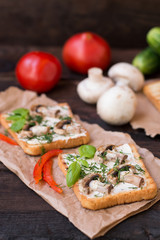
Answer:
[0, 46, 160, 240]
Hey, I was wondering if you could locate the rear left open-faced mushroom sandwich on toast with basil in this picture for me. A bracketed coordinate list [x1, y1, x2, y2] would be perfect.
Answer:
[0, 103, 89, 155]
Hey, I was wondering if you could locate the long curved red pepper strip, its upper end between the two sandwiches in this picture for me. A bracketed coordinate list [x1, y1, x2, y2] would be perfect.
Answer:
[33, 149, 62, 183]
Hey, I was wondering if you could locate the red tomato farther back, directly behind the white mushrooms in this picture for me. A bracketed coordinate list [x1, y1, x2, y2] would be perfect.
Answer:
[63, 32, 111, 73]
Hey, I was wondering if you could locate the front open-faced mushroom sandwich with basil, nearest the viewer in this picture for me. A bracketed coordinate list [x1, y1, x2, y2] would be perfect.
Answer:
[58, 144, 157, 210]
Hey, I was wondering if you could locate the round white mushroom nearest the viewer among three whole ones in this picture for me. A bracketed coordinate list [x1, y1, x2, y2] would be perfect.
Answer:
[97, 86, 137, 125]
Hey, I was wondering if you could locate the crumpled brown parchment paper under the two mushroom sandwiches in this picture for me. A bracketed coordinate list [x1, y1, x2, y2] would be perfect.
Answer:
[0, 87, 160, 238]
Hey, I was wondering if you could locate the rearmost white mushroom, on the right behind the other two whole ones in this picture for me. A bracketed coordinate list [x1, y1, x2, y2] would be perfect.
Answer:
[108, 62, 144, 92]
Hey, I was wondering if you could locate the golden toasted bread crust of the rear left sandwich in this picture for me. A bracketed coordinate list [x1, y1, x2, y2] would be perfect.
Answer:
[0, 103, 90, 156]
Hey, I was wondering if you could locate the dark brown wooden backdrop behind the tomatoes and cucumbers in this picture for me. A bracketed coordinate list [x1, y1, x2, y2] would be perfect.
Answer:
[0, 0, 160, 48]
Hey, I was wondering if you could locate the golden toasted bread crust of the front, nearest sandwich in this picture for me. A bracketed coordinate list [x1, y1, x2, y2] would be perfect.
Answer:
[58, 144, 157, 210]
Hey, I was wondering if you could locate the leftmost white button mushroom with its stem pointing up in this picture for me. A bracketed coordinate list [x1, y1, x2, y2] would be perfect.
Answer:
[77, 68, 114, 103]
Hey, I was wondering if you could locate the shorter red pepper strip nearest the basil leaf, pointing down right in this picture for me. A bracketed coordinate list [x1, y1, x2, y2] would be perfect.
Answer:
[42, 159, 63, 193]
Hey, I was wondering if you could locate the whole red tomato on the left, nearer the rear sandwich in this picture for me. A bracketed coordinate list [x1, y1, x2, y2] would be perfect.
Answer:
[16, 51, 62, 93]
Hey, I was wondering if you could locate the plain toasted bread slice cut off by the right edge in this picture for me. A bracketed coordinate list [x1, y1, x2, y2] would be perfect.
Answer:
[143, 80, 160, 111]
